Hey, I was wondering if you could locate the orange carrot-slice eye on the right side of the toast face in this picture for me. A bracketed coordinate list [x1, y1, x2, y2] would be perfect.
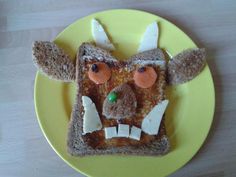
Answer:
[134, 66, 157, 88]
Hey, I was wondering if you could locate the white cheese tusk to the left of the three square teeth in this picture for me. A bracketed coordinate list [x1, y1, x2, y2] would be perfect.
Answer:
[82, 96, 102, 134]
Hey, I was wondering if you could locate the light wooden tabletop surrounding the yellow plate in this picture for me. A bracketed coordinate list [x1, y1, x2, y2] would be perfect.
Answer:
[0, 0, 236, 177]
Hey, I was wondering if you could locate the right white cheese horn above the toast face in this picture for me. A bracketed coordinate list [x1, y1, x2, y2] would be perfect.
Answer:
[138, 22, 159, 52]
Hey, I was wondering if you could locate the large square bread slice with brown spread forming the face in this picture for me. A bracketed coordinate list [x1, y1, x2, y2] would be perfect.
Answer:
[67, 43, 170, 156]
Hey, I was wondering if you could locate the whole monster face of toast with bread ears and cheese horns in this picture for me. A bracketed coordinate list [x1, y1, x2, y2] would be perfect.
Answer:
[33, 20, 206, 156]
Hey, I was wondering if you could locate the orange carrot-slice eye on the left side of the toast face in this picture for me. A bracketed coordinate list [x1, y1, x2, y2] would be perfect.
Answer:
[88, 62, 111, 84]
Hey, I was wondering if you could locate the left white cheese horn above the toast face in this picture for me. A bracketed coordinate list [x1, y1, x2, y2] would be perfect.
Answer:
[92, 19, 115, 50]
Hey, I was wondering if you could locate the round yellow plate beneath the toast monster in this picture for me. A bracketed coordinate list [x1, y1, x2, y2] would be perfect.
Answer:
[34, 9, 215, 177]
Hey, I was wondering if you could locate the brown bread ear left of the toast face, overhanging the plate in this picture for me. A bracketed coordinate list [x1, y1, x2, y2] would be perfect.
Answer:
[32, 41, 75, 82]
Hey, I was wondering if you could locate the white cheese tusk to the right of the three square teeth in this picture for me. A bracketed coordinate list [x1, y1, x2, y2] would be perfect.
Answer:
[141, 100, 169, 135]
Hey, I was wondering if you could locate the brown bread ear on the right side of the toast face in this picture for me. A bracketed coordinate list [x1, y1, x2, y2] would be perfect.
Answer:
[167, 49, 206, 85]
